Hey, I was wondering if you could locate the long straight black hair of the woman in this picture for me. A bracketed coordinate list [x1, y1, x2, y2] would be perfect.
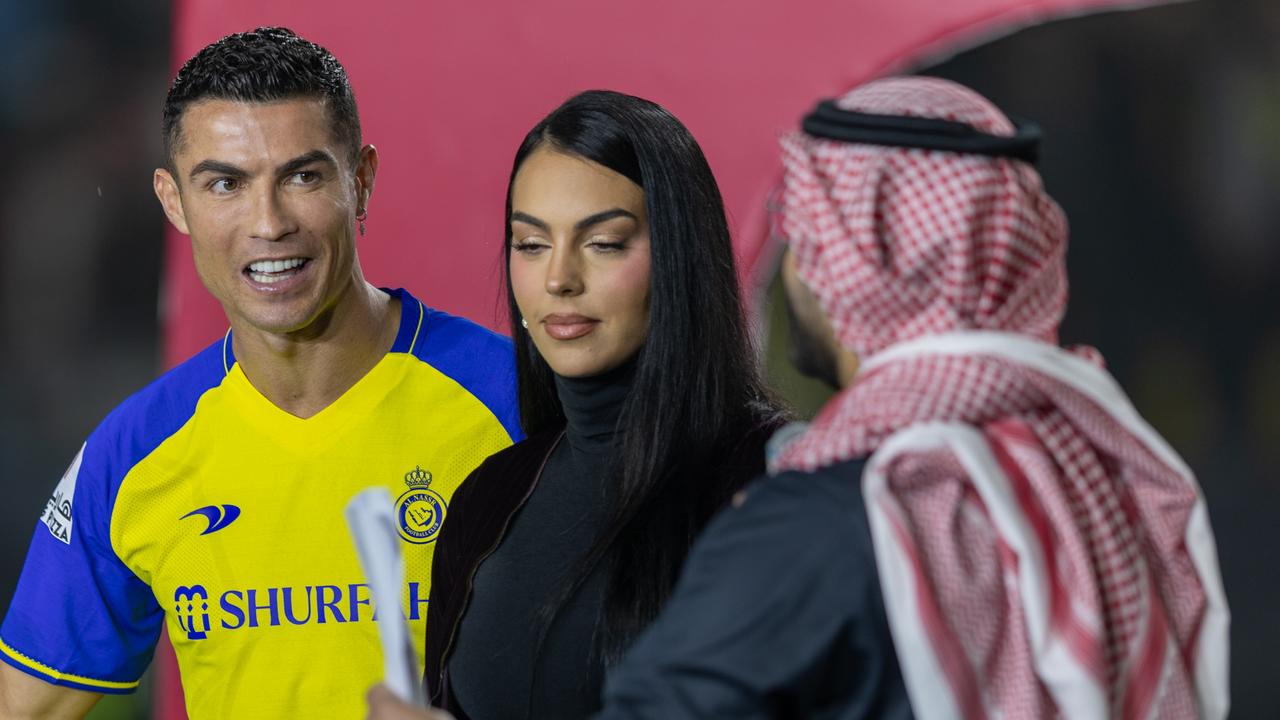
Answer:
[506, 91, 780, 664]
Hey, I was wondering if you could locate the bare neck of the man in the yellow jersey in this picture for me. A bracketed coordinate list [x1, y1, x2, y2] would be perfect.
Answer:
[232, 282, 401, 418]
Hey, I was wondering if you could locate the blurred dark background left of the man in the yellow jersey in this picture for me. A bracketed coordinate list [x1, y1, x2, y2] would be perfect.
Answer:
[0, 0, 170, 720]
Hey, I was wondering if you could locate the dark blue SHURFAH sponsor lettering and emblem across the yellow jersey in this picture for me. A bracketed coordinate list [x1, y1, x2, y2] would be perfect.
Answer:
[165, 582, 428, 641]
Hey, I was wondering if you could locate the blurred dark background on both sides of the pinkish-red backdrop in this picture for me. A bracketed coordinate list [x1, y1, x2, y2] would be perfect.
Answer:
[0, 0, 1280, 720]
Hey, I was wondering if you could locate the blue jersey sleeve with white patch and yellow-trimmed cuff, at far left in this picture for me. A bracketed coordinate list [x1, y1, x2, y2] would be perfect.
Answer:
[0, 432, 164, 693]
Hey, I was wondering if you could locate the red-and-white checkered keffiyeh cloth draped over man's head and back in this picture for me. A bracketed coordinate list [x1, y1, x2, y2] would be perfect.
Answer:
[774, 78, 1229, 719]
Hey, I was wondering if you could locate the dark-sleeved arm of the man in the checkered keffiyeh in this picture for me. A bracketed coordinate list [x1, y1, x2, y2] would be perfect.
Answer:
[595, 465, 910, 720]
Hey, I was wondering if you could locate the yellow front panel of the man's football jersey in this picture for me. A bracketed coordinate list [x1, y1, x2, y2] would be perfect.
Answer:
[110, 352, 511, 720]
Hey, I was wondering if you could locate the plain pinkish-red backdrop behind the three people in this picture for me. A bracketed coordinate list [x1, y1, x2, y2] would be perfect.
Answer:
[156, 0, 1172, 720]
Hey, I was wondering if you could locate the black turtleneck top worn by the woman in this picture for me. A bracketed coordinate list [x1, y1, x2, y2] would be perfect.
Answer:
[449, 363, 635, 720]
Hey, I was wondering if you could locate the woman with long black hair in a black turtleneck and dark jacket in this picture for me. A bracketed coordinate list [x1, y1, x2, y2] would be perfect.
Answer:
[414, 91, 780, 720]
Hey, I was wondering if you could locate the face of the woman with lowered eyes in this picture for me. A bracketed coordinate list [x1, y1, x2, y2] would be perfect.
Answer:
[509, 147, 649, 378]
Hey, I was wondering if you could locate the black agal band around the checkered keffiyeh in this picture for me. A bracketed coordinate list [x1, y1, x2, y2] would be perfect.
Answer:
[800, 100, 1041, 163]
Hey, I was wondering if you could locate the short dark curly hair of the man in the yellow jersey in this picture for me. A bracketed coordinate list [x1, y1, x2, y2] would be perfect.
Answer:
[163, 27, 361, 170]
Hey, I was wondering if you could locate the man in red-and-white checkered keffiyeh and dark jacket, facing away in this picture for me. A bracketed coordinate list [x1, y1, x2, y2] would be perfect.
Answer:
[607, 78, 1229, 720]
